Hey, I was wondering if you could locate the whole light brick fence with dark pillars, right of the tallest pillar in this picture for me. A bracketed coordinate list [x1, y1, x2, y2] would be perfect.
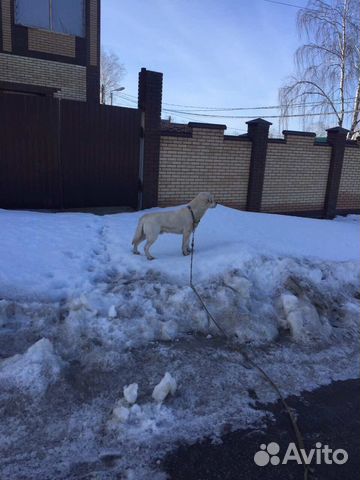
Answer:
[158, 119, 360, 218]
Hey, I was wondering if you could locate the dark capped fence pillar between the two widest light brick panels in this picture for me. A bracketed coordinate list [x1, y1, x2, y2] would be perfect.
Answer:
[246, 118, 272, 212]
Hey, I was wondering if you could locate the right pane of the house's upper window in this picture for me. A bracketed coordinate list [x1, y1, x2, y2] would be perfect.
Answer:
[52, 0, 85, 37]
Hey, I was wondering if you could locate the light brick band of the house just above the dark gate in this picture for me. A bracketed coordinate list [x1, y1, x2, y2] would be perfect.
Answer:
[0, 53, 86, 101]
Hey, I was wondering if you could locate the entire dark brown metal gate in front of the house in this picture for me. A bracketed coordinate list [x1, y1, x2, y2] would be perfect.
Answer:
[0, 95, 141, 208]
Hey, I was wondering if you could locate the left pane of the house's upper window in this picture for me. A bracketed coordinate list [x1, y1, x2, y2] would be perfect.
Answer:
[15, 0, 50, 29]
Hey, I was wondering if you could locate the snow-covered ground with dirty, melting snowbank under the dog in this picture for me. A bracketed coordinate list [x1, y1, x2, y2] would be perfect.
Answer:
[0, 206, 360, 479]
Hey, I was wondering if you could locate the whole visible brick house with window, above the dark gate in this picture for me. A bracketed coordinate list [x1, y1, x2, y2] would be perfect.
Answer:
[0, 0, 100, 102]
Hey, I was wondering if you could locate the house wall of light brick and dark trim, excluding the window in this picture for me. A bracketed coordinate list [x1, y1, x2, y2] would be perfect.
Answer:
[0, 0, 100, 103]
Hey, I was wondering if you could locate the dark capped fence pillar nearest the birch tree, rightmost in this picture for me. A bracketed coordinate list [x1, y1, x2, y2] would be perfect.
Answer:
[324, 127, 349, 218]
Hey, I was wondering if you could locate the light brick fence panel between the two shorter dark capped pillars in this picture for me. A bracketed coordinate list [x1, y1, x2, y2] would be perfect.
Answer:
[261, 133, 331, 212]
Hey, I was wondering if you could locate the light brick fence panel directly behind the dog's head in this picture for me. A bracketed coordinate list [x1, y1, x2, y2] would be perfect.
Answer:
[158, 124, 251, 208]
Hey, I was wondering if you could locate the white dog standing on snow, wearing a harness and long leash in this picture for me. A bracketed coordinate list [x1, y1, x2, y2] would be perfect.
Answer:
[132, 192, 216, 260]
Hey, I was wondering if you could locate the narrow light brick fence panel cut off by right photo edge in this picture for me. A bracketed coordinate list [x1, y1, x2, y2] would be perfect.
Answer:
[337, 146, 360, 210]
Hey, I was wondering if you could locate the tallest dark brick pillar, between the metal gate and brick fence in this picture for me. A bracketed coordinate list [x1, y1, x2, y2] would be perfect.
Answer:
[138, 68, 163, 208]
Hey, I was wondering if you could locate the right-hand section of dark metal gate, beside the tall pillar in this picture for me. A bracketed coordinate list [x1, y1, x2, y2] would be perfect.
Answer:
[61, 100, 140, 208]
